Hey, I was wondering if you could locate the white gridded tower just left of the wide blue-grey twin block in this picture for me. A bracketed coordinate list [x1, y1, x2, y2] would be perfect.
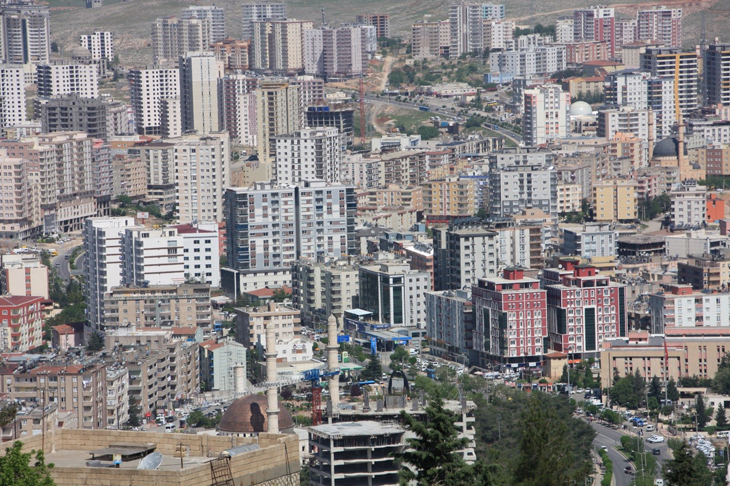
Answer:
[174, 132, 231, 223]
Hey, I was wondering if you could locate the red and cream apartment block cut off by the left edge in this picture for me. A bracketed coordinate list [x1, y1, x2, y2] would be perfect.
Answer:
[0, 295, 43, 352]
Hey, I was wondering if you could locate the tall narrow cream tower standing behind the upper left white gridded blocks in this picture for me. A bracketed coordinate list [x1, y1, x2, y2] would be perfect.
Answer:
[180, 52, 224, 135]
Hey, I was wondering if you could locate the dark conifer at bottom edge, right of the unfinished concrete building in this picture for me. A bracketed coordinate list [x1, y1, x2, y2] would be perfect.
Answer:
[395, 397, 472, 486]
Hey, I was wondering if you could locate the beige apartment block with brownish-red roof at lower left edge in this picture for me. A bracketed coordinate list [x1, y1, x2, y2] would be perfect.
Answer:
[0, 359, 107, 429]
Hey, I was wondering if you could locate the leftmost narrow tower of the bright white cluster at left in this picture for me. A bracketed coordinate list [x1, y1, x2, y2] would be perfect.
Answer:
[84, 217, 135, 329]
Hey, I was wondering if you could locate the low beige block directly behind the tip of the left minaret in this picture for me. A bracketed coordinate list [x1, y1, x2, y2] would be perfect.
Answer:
[234, 302, 301, 349]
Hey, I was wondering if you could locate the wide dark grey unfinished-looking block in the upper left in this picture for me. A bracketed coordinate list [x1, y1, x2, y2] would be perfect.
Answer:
[40, 93, 108, 140]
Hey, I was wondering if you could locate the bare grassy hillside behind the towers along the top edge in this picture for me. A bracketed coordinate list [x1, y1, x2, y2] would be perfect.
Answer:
[47, 0, 730, 64]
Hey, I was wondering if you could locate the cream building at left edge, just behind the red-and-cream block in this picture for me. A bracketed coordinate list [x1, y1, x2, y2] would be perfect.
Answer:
[0, 254, 49, 299]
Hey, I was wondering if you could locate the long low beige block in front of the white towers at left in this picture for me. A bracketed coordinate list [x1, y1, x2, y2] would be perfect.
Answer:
[104, 283, 212, 329]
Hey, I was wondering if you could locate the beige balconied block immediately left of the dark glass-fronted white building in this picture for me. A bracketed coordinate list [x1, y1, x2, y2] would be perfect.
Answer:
[292, 260, 359, 325]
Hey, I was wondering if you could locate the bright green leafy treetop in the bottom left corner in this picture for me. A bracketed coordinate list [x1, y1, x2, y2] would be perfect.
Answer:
[0, 441, 56, 486]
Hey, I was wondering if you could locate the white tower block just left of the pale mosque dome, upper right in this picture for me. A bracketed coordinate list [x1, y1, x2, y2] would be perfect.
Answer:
[522, 84, 570, 147]
